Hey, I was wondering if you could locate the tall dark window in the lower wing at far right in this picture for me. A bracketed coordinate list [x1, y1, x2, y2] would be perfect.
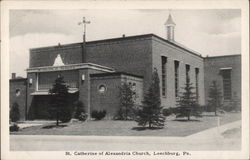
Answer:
[222, 69, 232, 100]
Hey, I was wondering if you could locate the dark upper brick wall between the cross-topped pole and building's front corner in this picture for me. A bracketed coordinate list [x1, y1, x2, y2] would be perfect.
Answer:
[86, 35, 152, 94]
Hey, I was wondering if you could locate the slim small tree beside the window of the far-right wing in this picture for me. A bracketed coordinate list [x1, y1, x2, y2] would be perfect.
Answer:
[208, 81, 222, 116]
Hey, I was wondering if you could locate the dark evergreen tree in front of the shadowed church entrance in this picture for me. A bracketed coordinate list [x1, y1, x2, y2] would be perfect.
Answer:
[49, 76, 71, 126]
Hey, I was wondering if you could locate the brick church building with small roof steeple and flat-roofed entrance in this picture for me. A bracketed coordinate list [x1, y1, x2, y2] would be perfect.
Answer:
[10, 15, 241, 120]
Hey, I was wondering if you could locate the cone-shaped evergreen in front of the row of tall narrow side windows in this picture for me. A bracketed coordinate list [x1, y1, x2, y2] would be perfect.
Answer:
[175, 78, 201, 120]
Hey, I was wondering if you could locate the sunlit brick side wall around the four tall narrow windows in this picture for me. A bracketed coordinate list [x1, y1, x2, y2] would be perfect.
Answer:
[152, 38, 205, 107]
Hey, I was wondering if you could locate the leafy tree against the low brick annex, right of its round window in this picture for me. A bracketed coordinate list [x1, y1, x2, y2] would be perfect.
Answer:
[117, 83, 136, 120]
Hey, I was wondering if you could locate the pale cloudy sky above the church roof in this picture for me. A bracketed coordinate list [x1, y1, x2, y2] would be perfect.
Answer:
[9, 9, 241, 77]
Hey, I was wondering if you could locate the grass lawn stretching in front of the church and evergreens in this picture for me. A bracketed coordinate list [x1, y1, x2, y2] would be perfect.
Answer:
[11, 113, 241, 136]
